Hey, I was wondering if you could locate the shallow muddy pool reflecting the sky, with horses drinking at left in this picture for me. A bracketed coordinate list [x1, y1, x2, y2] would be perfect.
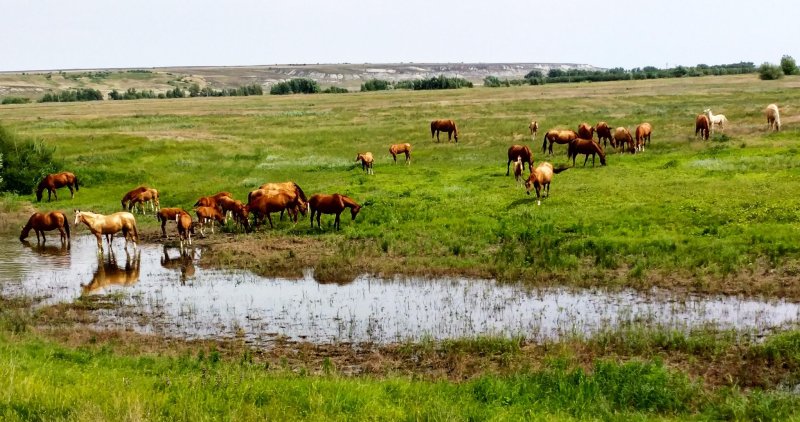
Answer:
[0, 236, 800, 344]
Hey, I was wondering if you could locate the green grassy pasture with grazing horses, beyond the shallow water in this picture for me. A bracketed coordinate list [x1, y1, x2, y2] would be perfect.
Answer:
[2, 75, 800, 298]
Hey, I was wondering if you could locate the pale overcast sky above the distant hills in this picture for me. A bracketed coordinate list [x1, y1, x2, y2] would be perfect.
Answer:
[0, 0, 800, 71]
